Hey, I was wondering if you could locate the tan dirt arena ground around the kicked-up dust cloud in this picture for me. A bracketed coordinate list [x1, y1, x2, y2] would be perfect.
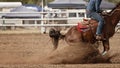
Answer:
[0, 31, 120, 68]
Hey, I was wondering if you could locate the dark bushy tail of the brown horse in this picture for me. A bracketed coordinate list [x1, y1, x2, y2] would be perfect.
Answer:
[49, 28, 64, 49]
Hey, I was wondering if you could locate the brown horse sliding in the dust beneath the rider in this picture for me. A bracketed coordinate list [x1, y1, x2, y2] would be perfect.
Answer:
[49, 3, 120, 55]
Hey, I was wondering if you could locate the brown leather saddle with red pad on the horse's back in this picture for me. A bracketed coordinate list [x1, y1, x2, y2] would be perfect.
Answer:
[77, 19, 105, 40]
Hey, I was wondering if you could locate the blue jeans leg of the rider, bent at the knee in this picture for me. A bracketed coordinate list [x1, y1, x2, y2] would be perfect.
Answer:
[87, 12, 104, 35]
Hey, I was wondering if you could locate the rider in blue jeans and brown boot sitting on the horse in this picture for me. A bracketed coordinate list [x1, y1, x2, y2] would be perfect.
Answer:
[86, 0, 104, 40]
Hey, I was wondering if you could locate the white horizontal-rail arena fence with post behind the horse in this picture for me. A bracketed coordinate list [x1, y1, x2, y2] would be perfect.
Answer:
[0, 11, 120, 33]
